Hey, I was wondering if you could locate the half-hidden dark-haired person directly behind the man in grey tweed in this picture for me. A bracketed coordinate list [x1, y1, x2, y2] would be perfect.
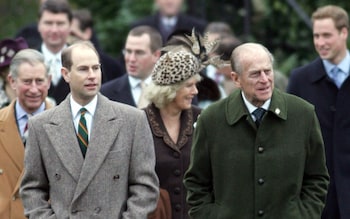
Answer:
[68, 9, 125, 83]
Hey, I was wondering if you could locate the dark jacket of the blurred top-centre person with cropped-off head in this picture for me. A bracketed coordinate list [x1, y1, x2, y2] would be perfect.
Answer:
[131, 12, 207, 42]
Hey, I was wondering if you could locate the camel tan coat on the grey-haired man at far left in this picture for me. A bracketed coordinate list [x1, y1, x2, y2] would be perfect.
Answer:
[0, 100, 51, 219]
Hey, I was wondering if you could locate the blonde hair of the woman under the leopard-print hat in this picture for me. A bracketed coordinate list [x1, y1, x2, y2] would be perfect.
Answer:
[145, 74, 201, 109]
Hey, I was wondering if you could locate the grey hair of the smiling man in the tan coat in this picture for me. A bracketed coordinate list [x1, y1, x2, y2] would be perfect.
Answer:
[9, 49, 49, 78]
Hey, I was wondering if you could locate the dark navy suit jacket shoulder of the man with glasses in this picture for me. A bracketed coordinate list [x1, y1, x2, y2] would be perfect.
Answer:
[101, 74, 136, 107]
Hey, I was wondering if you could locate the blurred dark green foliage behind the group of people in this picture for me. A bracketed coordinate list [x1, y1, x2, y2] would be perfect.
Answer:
[0, 0, 350, 76]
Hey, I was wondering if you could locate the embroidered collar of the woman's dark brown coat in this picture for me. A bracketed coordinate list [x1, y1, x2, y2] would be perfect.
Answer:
[145, 104, 194, 151]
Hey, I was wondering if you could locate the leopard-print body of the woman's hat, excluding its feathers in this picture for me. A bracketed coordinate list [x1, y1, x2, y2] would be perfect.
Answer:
[152, 50, 200, 85]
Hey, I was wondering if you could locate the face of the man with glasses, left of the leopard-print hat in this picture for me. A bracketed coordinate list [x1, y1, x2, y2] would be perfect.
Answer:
[124, 34, 160, 80]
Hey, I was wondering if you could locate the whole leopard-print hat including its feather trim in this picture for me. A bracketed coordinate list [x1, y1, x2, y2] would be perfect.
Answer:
[152, 29, 225, 85]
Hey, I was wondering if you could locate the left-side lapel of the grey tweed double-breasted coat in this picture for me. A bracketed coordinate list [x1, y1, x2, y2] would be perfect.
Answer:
[44, 96, 84, 181]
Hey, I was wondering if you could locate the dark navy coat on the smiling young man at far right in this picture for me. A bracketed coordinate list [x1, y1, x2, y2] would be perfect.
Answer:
[287, 58, 350, 219]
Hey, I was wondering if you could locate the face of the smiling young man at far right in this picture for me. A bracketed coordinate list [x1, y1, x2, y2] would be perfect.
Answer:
[313, 18, 348, 64]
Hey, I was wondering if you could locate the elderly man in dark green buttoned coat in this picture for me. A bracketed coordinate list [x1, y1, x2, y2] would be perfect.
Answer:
[184, 43, 329, 219]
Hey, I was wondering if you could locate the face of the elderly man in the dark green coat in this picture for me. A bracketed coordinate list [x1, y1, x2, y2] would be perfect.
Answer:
[231, 51, 274, 107]
